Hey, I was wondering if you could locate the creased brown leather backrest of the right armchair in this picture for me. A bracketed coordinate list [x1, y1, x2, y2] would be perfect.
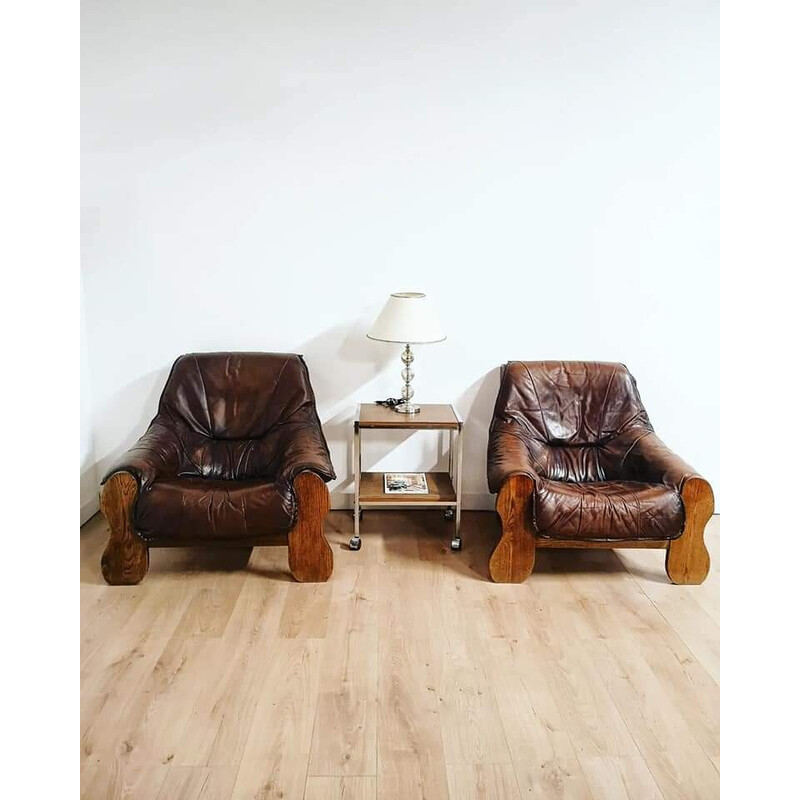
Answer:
[493, 361, 652, 482]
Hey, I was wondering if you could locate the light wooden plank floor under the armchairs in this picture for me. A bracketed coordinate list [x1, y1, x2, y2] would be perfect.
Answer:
[81, 511, 719, 800]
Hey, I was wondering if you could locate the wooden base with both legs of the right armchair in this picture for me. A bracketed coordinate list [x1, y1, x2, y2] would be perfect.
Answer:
[489, 475, 714, 584]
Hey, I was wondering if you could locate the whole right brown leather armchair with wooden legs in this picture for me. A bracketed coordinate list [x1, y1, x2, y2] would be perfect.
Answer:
[487, 361, 714, 584]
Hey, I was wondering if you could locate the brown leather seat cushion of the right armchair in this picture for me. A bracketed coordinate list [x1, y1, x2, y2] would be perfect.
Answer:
[534, 479, 684, 541]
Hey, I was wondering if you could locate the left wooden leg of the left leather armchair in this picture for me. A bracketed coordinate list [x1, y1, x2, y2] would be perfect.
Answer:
[100, 472, 150, 586]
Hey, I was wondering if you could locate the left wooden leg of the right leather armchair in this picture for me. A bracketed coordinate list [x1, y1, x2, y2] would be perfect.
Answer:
[489, 475, 536, 583]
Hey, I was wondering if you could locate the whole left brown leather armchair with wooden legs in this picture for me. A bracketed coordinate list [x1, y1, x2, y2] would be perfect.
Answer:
[100, 353, 336, 584]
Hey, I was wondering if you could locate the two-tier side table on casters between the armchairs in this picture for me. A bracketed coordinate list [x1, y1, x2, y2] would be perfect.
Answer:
[350, 403, 464, 550]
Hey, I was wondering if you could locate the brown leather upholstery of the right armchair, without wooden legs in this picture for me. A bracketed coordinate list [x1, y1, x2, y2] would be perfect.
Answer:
[488, 361, 696, 541]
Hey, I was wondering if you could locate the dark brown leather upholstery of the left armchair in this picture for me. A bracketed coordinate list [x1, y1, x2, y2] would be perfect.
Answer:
[103, 353, 335, 544]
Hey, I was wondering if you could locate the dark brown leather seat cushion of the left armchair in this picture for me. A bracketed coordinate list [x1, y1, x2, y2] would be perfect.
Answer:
[136, 478, 294, 544]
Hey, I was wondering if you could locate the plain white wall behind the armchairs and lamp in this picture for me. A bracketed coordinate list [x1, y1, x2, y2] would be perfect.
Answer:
[82, 0, 719, 507]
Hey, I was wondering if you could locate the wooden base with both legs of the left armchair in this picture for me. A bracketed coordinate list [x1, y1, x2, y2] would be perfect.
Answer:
[100, 472, 333, 586]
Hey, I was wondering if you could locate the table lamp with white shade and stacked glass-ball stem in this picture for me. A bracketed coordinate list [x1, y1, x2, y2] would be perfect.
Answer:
[367, 292, 447, 414]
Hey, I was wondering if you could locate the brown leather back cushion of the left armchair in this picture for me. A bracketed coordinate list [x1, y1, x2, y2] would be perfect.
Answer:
[159, 353, 316, 438]
